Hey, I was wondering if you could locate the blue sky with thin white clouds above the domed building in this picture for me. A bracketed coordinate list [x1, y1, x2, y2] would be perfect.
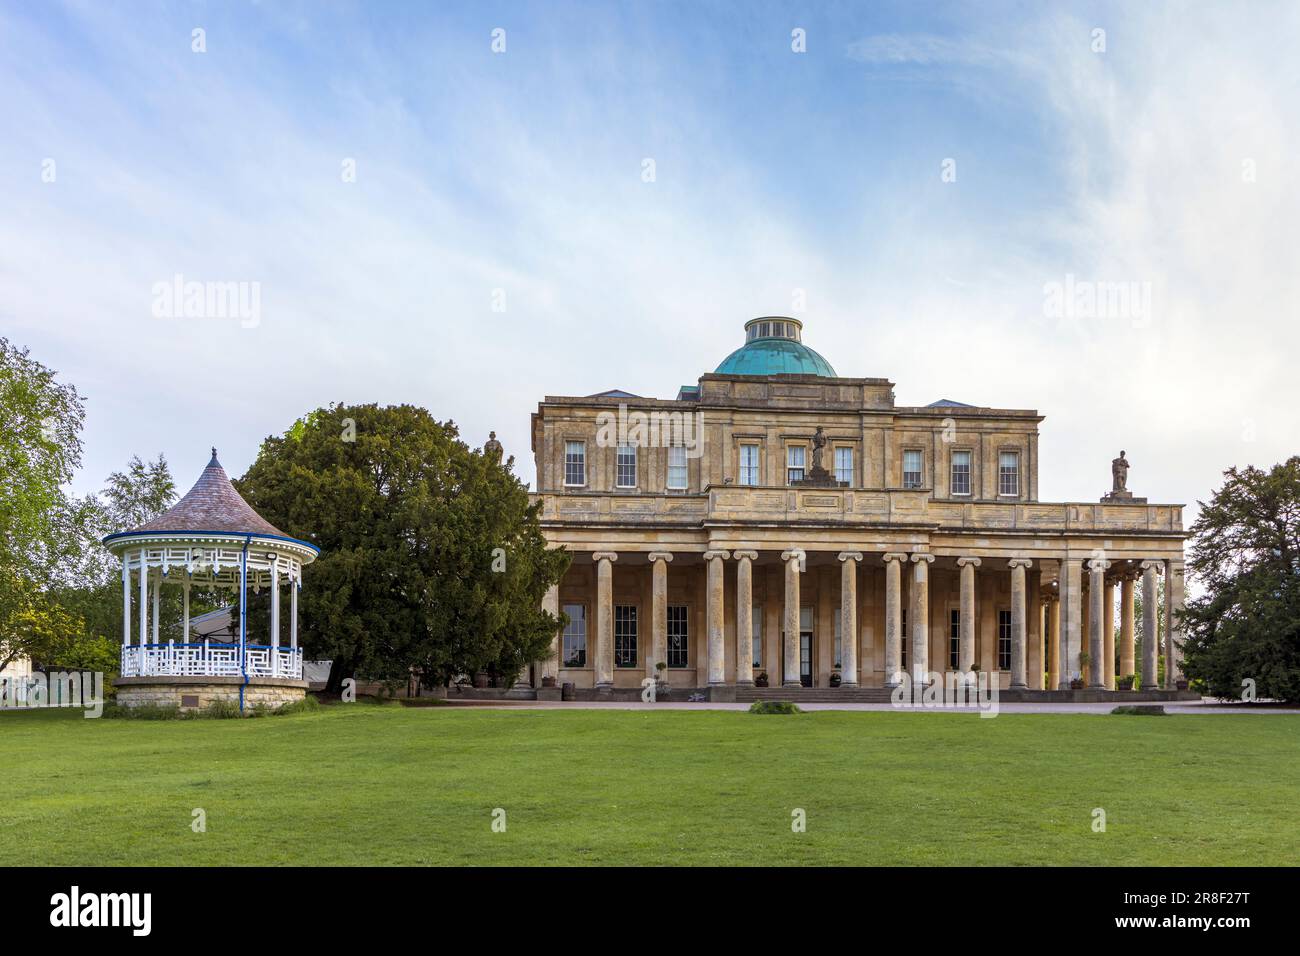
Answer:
[0, 0, 1300, 520]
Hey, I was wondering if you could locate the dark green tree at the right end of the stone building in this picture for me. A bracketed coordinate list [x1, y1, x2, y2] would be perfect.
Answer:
[1182, 457, 1300, 701]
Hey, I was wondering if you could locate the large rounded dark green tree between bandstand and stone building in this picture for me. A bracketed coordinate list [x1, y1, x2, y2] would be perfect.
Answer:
[237, 405, 569, 689]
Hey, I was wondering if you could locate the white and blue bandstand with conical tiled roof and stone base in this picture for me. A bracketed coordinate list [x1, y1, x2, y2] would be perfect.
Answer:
[104, 449, 320, 710]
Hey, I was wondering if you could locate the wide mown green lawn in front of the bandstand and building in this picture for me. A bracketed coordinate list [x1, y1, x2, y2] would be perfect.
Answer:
[0, 704, 1300, 865]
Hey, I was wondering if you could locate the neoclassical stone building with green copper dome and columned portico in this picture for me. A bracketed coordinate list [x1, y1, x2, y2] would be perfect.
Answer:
[532, 316, 1184, 696]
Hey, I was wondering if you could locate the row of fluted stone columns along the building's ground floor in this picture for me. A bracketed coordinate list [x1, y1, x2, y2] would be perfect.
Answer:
[541, 546, 1183, 691]
